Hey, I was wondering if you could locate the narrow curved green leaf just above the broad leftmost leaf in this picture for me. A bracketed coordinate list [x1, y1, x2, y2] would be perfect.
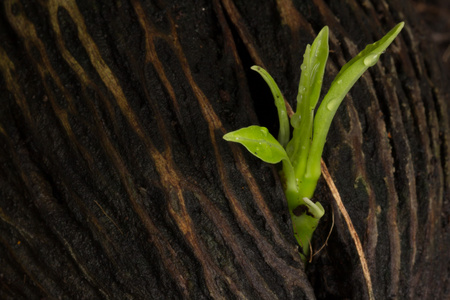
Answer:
[251, 66, 290, 147]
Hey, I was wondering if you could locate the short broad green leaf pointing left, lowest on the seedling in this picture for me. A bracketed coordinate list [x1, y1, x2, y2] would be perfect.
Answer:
[223, 125, 287, 164]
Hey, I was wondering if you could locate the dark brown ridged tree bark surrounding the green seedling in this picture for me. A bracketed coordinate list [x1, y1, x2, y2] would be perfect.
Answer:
[0, 0, 450, 299]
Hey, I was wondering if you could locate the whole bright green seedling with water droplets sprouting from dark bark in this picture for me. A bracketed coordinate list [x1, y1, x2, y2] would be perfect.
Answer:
[223, 22, 404, 261]
